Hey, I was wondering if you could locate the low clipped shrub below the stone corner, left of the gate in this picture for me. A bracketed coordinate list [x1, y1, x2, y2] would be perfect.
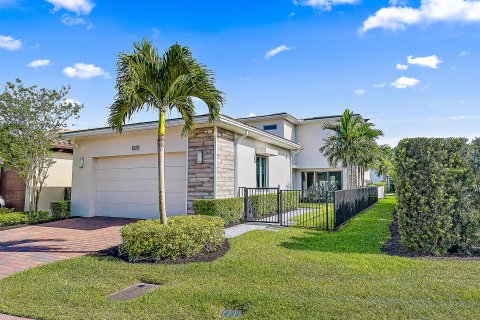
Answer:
[193, 198, 244, 225]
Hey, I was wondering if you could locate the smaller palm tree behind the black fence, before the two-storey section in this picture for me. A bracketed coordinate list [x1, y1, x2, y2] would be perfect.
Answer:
[320, 109, 383, 189]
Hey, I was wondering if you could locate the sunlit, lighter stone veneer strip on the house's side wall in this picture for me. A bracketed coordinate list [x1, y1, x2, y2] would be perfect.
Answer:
[216, 128, 235, 198]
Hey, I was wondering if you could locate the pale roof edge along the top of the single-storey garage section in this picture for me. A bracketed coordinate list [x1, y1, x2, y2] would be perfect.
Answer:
[63, 115, 302, 150]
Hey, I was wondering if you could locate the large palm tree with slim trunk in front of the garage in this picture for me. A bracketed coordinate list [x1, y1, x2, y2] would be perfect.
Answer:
[108, 39, 224, 224]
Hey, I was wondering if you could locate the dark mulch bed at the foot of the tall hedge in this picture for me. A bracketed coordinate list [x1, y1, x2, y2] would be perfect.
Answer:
[382, 211, 480, 260]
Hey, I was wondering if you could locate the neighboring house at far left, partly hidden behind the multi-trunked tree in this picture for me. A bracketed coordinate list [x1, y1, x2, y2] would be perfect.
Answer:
[0, 144, 73, 211]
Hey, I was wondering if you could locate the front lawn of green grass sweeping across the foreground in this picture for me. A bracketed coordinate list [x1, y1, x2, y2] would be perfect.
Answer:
[0, 198, 480, 320]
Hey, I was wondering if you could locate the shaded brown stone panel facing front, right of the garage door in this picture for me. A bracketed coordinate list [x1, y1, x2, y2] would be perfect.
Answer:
[187, 127, 215, 214]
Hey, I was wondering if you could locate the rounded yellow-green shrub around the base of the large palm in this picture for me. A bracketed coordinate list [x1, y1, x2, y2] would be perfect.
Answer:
[121, 215, 225, 262]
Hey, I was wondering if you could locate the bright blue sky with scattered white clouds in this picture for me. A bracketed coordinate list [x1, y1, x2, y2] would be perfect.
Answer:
[0, 0, 480, 144]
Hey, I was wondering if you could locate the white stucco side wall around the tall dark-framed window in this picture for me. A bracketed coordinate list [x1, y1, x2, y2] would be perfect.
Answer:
[236, 137, 291, 188]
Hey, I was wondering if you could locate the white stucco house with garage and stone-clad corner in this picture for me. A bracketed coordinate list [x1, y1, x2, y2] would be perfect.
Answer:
[65, 113, 352, 218]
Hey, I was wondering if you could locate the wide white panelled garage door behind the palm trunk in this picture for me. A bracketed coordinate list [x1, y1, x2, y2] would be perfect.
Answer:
[95, 152, 187, 219]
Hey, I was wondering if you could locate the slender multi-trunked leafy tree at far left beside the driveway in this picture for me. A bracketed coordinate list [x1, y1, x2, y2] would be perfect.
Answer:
[0, 79, 83, 212]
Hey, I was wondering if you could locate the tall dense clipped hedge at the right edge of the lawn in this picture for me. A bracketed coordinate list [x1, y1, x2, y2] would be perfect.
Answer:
[395, 138, 480, 255]
